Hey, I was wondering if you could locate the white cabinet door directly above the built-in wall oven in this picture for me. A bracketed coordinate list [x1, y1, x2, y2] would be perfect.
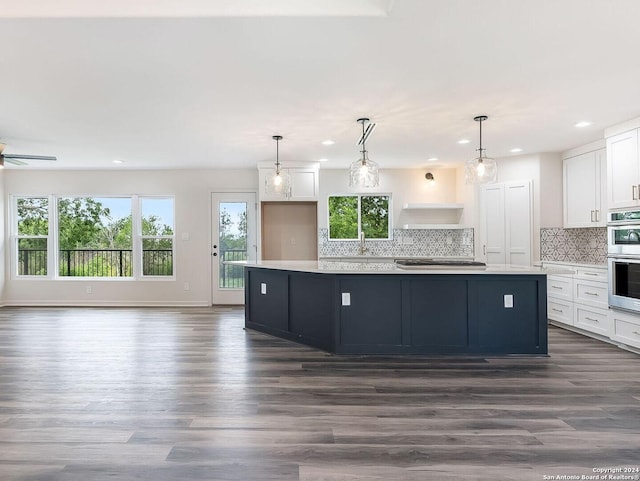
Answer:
[607, 130, 640, 209]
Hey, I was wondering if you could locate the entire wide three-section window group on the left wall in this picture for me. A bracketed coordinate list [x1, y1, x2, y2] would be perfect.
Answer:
[13, 196, 175, 279]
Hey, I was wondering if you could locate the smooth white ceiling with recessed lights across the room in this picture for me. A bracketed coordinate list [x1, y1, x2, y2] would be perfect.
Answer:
[0, 0, 640, 169]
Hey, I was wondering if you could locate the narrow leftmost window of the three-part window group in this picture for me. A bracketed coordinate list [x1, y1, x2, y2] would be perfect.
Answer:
[15, 197, 49, 276]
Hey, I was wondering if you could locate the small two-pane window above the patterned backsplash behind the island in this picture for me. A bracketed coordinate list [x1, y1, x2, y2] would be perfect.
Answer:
[329, 195, 391, 240]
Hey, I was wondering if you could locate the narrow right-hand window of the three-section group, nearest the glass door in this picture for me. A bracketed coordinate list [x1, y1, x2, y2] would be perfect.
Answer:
[140, 197, 174, 276]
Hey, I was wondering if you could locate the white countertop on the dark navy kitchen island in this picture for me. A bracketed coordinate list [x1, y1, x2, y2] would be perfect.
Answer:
[235, 260, 563, 275]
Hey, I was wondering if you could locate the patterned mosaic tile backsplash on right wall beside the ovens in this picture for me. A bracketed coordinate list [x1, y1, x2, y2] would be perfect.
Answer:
[540, 227, 607, 264]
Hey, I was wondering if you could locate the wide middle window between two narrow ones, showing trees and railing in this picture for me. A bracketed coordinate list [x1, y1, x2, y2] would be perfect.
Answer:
[58, 197, 133, 277]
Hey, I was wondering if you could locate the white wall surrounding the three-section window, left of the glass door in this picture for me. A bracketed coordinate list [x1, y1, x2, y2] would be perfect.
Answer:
[0, 169, 258, 306]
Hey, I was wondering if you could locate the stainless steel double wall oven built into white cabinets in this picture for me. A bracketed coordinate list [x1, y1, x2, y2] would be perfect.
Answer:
[607, 211, 640, 312]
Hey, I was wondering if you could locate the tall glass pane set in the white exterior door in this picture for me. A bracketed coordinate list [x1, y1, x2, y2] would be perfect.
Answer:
[218, 202, 248, 289]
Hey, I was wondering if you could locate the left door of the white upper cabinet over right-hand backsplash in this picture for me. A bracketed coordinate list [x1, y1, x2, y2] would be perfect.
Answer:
[563, 152, 600, 228]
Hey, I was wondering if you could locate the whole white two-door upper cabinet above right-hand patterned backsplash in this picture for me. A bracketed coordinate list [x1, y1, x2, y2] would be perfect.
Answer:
[563, 149, 607, 228]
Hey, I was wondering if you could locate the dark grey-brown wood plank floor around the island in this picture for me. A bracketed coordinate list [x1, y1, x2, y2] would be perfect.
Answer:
[0, 308, 640, 481]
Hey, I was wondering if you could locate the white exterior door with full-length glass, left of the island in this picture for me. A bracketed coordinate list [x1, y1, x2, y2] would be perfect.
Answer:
[211, 192, 257, 304]
